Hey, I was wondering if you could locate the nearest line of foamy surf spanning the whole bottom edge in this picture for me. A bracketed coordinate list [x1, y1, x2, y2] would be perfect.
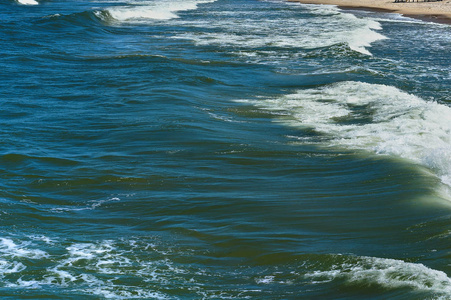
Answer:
[0, 235, 451, 299]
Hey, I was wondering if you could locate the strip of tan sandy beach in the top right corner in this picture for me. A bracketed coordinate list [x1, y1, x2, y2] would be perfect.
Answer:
[287, 0, 451, 25]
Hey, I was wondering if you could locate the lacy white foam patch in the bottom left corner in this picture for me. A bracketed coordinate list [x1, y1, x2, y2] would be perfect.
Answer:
[0, 235, 173, 299]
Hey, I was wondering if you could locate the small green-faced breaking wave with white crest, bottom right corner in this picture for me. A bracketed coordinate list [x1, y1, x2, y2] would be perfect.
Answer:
[254, 254, 451, 299]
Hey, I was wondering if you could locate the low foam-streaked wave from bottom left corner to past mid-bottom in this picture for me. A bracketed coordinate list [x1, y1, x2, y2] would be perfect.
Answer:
[0, 235, 262, 299]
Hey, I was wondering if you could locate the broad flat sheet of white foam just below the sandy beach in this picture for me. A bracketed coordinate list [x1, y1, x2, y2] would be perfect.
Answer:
[174, 5, 386, 57]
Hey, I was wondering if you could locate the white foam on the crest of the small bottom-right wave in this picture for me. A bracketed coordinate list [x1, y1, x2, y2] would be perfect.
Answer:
[305, 257, 451, 296]
